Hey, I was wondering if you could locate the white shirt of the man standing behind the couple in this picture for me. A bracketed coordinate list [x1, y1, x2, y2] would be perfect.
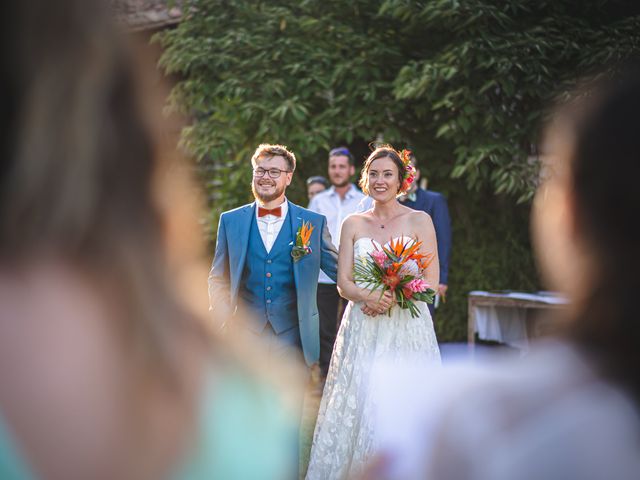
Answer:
[309, 184, 367, 283]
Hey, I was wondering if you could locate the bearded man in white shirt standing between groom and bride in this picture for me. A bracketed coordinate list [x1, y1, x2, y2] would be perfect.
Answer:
[309, 147, 365, 378]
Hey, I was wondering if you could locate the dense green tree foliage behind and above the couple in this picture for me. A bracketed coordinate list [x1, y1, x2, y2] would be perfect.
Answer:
[157, 0, 640, 342]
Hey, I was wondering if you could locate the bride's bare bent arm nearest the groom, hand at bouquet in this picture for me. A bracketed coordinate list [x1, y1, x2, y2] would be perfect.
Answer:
[338, 215, 393, 311]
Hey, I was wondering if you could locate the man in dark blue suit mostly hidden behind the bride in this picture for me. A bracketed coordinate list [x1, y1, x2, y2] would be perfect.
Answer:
[400, 151, 451, 317]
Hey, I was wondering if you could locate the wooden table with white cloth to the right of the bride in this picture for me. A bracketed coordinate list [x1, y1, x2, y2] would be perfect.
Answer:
[467, 291, 567, 348]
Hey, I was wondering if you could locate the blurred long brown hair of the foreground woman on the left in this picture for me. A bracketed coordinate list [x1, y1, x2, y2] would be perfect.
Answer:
[0, 0, 158, 262]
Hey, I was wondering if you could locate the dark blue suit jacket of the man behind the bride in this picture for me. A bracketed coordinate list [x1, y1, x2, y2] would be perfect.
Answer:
[403, 187, 451, 285]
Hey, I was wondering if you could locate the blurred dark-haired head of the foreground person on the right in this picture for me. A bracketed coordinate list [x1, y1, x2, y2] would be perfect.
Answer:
[533, 67, 640, 400]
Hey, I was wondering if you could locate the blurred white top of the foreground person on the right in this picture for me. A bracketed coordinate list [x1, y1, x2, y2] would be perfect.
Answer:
[378, 343, 640, 480]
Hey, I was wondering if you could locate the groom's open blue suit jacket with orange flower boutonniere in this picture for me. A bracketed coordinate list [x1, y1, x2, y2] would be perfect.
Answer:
[209, 202, 338, 365]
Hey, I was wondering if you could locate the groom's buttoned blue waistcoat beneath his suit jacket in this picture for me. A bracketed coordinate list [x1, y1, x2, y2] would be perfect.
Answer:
[238, 212, 298, 334]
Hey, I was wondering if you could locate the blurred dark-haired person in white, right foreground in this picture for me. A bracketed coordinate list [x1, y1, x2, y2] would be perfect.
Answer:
[369, 70, 640, 480]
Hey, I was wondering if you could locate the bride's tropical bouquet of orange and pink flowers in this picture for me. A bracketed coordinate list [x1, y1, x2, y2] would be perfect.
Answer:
[353, 238, 435, 317]
